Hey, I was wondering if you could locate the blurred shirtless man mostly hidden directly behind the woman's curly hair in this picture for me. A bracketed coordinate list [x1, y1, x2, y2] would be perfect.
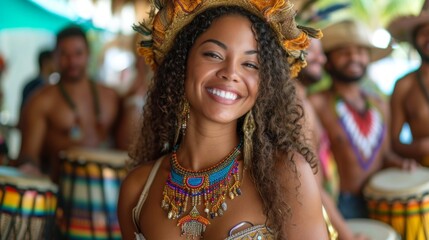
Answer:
[296, 39, 367, 240]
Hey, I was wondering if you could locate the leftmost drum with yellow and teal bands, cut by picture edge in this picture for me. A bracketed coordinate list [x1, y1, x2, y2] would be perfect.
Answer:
[0, 167, 58, 240]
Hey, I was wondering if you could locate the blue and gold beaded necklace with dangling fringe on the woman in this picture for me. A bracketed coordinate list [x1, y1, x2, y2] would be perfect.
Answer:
[161, 141, 242, 239]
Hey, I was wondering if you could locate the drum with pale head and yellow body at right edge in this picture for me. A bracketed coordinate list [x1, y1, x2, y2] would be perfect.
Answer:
[364, 168, 429, 240]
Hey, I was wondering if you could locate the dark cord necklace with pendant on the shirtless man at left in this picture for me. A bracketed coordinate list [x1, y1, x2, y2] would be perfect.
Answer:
[58, 80, 101, 141]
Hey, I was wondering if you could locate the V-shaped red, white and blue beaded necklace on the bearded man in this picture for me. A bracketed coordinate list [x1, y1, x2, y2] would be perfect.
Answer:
[335, 96, 385, 171]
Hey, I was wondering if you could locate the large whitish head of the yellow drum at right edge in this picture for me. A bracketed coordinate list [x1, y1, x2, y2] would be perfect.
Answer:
[364, 167, 429, 199]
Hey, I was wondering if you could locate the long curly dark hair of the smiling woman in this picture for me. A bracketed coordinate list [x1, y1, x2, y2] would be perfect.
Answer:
[130, 4, 316, 239]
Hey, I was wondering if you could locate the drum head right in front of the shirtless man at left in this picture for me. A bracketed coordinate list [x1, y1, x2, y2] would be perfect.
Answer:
[60, 148, 129, 167]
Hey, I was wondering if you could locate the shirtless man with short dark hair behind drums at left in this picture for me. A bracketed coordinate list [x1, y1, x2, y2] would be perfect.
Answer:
[18, 27, 119, 182]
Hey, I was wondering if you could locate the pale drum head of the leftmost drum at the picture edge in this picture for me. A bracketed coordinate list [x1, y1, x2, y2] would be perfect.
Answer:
[0, 166, 58, 193]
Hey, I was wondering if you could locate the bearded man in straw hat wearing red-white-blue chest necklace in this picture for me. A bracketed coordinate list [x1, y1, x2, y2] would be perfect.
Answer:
[310, 20, 410, 219]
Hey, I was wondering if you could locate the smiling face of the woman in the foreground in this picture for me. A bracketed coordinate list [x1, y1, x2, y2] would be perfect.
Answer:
[185, 15, 259, 123]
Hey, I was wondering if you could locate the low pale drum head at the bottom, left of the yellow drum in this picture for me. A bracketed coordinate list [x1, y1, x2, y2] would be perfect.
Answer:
[347, 219, 401, 240]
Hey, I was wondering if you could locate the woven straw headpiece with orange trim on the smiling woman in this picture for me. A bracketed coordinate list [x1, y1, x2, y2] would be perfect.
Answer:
[134, 0, 322, 77]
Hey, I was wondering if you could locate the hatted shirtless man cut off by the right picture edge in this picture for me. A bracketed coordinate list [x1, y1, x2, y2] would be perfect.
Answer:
[389, 1, 429, 167]
